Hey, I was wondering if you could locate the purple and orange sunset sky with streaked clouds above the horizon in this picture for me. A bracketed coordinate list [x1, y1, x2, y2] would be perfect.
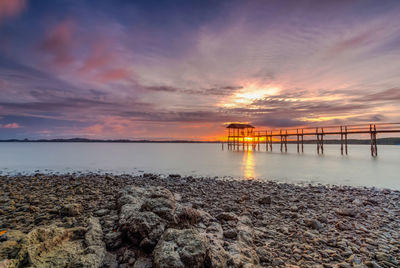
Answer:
[0, 0, 400, 140]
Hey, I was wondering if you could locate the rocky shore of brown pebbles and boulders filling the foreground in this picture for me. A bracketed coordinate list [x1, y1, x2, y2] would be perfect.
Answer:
[0, 174, 400, 268]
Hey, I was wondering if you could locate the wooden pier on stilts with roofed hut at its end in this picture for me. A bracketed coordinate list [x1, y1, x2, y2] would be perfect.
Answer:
[222, 123, 400, 157]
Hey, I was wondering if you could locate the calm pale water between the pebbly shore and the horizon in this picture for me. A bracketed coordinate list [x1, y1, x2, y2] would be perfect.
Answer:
[0, 143, 400, 189]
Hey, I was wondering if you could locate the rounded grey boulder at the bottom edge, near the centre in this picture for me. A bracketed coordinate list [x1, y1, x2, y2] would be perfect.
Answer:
[154, 229, 206, 268]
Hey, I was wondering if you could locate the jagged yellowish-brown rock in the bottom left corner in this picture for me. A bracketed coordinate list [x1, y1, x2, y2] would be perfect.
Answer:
[0, 218, 105, 267]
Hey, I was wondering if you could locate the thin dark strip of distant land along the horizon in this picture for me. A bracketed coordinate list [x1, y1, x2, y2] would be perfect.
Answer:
[0, 137, 400, 145]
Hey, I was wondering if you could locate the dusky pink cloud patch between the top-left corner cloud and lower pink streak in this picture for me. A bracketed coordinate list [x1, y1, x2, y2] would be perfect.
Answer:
[40, 20, 75, 65]
